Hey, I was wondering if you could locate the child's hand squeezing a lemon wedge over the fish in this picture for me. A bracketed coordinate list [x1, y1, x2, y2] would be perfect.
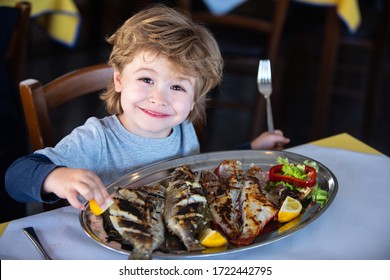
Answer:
[42, 167, 110, 209]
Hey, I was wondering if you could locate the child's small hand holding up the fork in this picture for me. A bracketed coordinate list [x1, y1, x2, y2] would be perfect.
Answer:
[251, 129, 290, 150]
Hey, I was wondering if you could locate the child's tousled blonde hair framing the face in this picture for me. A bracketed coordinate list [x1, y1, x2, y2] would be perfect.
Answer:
[101, 5, 223, 123]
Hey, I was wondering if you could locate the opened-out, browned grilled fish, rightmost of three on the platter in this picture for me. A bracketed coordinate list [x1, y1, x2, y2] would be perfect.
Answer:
[202, 160, 278, 245]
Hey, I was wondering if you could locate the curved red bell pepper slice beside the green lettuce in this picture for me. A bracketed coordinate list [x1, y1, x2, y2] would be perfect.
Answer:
[269, 164, 317, 188]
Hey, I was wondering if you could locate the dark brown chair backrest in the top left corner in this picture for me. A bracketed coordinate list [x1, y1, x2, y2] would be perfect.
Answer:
[1, 2, 31, 84]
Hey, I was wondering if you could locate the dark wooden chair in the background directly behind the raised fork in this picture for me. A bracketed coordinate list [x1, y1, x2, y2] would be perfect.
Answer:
[176, 0, 289, 138]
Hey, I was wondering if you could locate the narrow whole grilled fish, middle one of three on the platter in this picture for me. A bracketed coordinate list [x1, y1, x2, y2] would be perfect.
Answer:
[164, 166, 208, 251]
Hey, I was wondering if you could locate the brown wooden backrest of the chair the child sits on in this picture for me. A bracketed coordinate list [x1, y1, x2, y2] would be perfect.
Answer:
[19, 64, 113, 151]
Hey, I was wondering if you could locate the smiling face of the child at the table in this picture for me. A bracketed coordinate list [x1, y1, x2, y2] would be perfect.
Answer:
[114, 52, 196, 138]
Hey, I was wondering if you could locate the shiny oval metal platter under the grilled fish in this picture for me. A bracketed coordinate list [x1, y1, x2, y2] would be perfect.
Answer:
[80, 150, 338, 259]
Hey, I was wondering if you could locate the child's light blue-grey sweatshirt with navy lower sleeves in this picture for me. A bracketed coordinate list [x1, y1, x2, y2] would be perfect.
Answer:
[5, 115, 200, 202]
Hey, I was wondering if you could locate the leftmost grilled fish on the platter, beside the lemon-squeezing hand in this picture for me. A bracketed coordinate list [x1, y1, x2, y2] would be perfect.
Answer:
[109, 185, 165, 259]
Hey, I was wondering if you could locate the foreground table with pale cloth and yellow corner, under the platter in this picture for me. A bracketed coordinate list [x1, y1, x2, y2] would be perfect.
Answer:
[0, 133, 390, 260]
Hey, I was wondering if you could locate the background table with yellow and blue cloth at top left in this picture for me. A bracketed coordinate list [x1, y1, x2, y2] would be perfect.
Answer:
[0, 0, 81, 47]
